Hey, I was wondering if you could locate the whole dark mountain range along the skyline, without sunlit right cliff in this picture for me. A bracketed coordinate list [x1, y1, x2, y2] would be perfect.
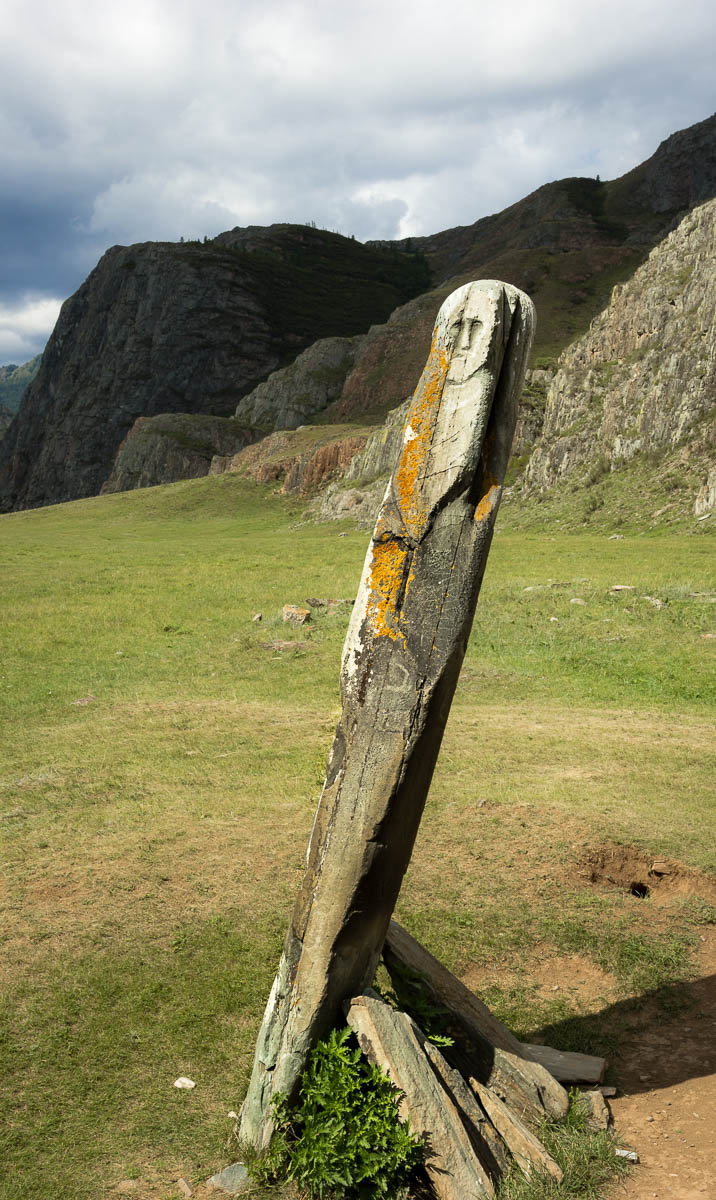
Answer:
[0, 106, 716, 509]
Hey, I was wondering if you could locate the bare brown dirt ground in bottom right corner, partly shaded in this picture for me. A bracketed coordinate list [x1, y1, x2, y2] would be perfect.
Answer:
[609, 926, 716, 1200]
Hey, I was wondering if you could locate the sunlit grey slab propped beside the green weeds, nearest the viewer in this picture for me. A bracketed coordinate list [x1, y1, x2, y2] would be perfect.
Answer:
[347, 996, 494, 1200]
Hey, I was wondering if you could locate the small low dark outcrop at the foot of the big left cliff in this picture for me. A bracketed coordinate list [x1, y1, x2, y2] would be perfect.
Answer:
[102, 413, 263, 492]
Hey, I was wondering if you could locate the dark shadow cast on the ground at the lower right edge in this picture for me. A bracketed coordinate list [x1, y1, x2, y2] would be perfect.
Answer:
[524, 974, 716, 1096]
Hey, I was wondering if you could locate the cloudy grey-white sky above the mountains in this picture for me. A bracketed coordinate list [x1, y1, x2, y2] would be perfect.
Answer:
[0, 0, 716, 364]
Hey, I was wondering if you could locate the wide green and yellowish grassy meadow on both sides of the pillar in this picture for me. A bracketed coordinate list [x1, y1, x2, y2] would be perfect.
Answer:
[0, 475, 716, 1200]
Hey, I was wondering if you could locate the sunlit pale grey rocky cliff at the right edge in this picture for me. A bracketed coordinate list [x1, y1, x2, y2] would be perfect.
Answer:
[525, 200, 716, 488]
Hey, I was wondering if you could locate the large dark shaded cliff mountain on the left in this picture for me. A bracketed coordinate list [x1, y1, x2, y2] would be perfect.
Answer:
[0, 226, 427, 510]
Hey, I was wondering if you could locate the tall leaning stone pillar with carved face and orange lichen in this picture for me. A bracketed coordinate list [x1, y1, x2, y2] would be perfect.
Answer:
[240, 280, 535, 1150]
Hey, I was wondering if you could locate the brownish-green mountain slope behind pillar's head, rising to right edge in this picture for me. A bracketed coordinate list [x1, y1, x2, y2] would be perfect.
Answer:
[227, 116, 716, 441]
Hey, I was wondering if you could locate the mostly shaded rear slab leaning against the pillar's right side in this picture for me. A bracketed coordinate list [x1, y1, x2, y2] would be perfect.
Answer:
[383, 920, 570, 1126]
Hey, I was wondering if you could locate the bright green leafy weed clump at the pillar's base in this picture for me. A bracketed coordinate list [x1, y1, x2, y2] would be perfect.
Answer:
[251, 1028, 423, 1200]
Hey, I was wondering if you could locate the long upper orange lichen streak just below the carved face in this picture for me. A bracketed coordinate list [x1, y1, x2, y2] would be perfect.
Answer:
[395, 332, 450, 538]
